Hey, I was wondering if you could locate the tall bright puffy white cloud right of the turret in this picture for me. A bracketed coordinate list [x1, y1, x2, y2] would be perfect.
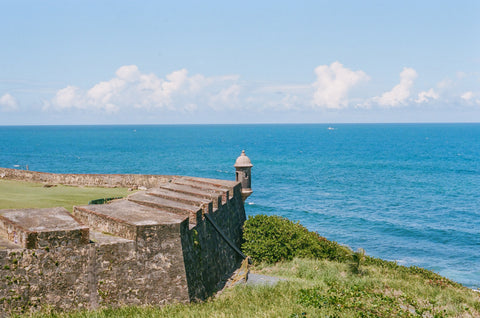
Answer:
[313, 62, 369, 109]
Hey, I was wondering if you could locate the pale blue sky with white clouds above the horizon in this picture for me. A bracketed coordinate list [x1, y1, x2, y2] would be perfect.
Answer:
[0, 0, 480, 125]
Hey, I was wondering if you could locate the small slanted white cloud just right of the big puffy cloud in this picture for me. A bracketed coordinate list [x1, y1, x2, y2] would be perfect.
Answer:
[373, 67, 417, 107]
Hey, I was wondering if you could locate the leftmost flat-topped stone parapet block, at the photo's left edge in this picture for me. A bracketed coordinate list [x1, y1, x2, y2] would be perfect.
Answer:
[0, 207, 90, 249]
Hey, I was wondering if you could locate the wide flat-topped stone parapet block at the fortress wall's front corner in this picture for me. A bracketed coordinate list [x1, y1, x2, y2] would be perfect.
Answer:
[73, 199, 188, 240]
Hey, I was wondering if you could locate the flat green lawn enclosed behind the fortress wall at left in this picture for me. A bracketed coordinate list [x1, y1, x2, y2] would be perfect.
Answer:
[0, 179, 129, 212]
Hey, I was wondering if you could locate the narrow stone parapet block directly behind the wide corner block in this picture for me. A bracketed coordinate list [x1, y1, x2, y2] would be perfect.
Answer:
[127, 192, 202, 224]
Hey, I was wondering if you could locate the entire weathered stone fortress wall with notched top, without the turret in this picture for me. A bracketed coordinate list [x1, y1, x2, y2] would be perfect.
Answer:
[0, 168, 245, 316]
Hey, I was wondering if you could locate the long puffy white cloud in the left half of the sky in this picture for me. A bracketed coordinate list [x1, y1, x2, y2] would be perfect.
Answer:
[44, 65, 240, 113]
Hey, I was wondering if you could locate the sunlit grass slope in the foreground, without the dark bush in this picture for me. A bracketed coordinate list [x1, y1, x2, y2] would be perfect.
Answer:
[18, 258, 480, 318]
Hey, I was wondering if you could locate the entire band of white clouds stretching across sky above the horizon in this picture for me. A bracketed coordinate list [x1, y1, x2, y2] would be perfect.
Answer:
[43, 61, 480, 119]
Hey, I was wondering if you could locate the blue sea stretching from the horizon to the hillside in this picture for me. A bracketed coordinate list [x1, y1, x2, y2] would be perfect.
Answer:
[0, 124, 480, 288]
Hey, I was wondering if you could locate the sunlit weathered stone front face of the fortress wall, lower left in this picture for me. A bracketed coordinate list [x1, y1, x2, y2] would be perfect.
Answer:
[0, 222, 189, 316]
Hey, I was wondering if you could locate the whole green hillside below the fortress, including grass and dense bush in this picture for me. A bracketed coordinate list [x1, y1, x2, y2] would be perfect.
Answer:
[15, 215, 480, 318]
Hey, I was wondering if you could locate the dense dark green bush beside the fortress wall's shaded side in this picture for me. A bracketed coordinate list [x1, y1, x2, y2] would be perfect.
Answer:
[242, 215, 351, 264]
